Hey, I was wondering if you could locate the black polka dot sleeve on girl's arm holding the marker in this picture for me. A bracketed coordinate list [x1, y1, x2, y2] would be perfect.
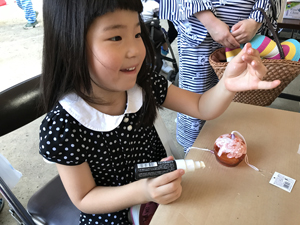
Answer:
[40, 104, 86, 165]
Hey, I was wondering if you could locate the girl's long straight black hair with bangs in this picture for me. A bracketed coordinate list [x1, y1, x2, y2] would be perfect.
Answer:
[41, 0, 159, 125]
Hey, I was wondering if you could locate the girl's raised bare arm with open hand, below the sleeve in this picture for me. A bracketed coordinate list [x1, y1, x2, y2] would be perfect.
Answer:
[163, 43, 280, 120]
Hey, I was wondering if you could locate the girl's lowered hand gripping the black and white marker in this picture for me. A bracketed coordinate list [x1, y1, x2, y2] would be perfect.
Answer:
[145, 156, 184, 204]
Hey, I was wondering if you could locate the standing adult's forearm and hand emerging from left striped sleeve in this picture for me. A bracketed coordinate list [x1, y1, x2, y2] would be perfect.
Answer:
[195, 10, 240, 48]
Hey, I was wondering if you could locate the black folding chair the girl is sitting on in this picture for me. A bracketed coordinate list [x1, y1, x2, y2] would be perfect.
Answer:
[0, 75, 80, 225]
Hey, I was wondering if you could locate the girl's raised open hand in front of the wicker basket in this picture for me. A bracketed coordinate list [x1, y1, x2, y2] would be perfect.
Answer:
[223, 43, 280, 92]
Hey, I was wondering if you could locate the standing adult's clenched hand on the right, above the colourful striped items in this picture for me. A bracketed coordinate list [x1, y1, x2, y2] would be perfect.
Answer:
[231, 19, 261, 44]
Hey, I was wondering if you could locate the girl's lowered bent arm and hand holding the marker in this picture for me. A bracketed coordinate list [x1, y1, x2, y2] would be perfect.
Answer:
[56, 157, 184, 214]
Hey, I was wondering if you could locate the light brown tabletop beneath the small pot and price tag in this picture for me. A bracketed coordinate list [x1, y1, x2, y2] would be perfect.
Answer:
[151, 102, 300, 225]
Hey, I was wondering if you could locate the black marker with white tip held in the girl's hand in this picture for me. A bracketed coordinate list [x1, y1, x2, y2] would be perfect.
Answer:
[135, 159, 205, 180]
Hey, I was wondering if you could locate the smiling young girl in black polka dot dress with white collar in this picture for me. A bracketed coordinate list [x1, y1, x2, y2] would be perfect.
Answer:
[40, 0, 279, 224]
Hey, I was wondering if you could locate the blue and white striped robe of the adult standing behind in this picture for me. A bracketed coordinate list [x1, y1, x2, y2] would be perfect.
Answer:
[160, 0, 280, 150]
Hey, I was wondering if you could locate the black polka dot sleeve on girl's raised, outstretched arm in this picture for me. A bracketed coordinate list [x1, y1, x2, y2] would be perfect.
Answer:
[151, 73, 168, 105]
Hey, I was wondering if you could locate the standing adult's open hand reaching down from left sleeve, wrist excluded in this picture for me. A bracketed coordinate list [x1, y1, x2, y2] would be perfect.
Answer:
[205, 17, 240, 49]
